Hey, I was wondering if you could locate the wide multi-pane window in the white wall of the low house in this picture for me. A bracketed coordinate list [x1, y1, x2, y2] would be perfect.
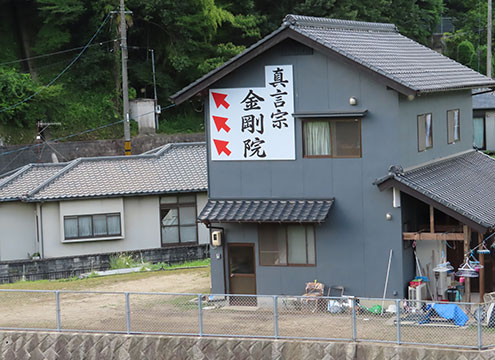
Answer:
[64, 213, 122, 240]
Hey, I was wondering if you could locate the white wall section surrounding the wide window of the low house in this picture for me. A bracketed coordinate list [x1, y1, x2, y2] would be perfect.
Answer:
[42, 196, 160, 257]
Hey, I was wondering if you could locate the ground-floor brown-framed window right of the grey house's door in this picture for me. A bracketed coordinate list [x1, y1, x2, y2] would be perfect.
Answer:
[258, 224, 316, 266]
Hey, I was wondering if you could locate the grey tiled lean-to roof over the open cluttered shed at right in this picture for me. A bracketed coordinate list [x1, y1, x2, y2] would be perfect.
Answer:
[375, 151, 495, 232]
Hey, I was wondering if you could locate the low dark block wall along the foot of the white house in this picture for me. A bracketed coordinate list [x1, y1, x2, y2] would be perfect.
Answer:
[0, 245, 209, 283]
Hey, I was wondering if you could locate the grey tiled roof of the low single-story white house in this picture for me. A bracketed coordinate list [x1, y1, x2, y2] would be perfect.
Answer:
[0, 143, 208, 201]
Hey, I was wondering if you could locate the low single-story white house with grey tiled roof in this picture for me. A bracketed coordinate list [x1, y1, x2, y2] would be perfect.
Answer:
[0, 143, 209, 261]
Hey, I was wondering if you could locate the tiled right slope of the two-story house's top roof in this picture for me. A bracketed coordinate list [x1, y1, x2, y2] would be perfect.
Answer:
[286, 15, 495, 92]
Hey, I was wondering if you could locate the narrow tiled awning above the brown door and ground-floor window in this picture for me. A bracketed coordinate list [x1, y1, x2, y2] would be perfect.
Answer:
[198, 199, 334, 224]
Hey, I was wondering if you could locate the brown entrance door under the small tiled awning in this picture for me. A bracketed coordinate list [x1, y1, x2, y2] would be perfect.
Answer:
[228, 243, 256, 305]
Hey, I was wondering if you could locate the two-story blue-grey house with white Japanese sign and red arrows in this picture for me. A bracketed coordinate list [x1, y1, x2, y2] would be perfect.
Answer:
[172, 15, 495, 297]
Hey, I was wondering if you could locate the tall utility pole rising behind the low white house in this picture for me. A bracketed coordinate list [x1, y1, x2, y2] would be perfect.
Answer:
[120, 0, 131, 155]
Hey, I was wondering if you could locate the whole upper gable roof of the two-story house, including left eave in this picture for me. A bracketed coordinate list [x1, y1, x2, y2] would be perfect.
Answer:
[171, 15, 495, 102]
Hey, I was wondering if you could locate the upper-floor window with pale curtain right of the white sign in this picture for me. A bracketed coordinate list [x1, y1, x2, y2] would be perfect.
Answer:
[303, 118, 361, 158]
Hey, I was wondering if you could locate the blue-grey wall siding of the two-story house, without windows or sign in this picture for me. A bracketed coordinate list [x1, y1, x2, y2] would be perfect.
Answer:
[205, 41, 472, 297]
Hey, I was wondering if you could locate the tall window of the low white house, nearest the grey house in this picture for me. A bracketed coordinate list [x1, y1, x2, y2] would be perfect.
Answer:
[160, 194, 198, 246]
